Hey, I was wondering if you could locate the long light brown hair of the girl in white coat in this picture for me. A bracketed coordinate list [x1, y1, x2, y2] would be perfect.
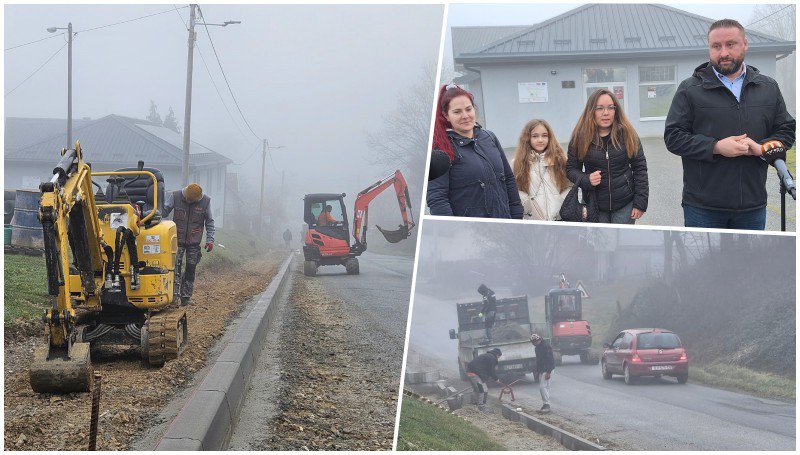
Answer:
[513, 119, 572, 193]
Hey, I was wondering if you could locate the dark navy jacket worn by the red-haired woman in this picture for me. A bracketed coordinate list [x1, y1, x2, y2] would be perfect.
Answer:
[427, 125, 522, 219]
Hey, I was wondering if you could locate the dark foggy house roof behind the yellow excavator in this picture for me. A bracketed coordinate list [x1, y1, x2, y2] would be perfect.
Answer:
[5, 114, 233, 168]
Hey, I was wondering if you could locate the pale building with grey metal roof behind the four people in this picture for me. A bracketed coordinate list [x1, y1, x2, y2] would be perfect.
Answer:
[453, 3, 795, 147]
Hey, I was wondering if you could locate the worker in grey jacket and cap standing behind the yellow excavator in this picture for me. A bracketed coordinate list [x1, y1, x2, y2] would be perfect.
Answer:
[164, 183, 215, 305]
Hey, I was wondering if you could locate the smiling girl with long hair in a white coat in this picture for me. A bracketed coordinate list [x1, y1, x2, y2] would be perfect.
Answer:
[513, 119, 572, 221]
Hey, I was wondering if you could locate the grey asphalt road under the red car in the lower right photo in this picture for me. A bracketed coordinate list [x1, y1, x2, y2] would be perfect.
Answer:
[409, 290, 795, 450]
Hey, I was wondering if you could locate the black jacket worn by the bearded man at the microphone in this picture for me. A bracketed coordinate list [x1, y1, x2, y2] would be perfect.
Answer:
[664, 62, 795, 211]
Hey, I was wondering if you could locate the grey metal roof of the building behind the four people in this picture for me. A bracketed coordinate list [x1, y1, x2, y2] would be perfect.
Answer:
[455, 3, 795, 64]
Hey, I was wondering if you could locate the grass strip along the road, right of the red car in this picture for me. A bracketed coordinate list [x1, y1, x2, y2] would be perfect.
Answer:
[689, 363, 796, 401]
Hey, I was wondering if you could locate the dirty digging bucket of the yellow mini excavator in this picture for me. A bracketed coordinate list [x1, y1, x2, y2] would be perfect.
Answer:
[30, 343, 92, 393]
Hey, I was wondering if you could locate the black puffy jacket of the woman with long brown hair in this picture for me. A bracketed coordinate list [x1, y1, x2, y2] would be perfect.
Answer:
[567, 135, 650, 212]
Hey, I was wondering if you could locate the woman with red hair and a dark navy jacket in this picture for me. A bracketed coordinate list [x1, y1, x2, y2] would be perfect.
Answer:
[427, 84, 522, 219]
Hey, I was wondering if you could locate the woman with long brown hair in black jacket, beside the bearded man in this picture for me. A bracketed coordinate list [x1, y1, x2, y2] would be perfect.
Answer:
[567, 89, 649, 224]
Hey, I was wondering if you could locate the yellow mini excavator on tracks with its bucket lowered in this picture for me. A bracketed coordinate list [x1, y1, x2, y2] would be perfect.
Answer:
[30, 141, 188, 393]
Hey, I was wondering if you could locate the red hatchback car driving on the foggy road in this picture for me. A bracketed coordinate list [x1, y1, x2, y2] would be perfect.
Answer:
[600, 329, 689, 385]
